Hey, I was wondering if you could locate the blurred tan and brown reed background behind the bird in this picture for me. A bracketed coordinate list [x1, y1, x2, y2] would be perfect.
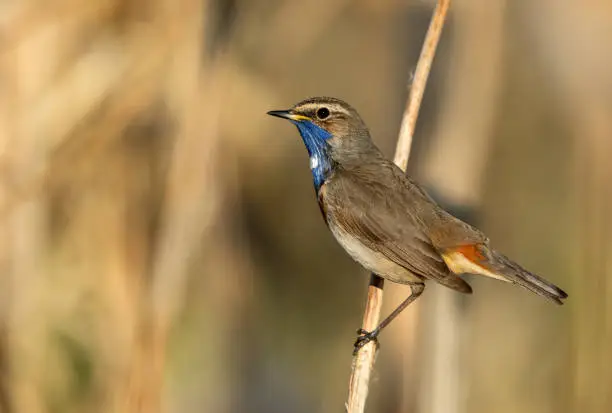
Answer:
[0, 0, 612, 413]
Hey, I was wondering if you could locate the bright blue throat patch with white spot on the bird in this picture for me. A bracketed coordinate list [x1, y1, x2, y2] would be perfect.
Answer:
[293, 121, 332, 192]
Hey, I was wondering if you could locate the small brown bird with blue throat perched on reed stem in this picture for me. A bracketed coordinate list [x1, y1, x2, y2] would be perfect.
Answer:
[268, 97, 567, 352]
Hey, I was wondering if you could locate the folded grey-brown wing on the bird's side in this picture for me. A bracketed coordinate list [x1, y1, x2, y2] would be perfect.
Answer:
[325, 161, 472, 293]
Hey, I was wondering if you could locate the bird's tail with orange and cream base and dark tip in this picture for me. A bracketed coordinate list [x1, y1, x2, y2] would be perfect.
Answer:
[442, 244, 567, 304]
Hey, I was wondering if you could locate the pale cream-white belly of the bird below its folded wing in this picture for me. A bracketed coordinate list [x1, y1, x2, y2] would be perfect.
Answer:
[329, 221, 421, 284]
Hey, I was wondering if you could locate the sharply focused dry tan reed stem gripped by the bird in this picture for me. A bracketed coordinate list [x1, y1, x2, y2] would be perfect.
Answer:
[346, 0, 450, 413]
